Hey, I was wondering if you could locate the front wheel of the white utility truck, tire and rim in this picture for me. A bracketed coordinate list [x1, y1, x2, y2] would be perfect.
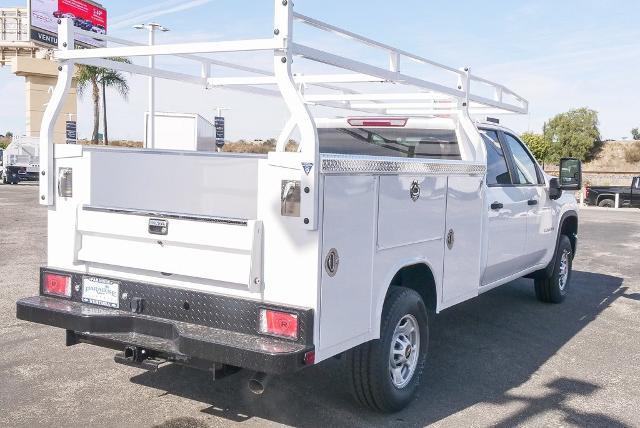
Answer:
[534, 235, 573, 303]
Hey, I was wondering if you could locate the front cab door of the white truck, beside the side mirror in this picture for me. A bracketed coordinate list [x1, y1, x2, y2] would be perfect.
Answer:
[503, 132, 556, 268]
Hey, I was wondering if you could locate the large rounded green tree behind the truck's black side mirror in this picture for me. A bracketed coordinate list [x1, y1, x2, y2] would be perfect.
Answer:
[544, 107, 601, 162]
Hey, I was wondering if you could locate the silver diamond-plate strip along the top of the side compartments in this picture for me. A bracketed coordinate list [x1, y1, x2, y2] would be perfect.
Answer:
[321, 154, 487, 175]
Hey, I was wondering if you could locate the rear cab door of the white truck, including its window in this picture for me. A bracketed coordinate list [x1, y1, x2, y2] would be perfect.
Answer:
[480, 130, 529, 285]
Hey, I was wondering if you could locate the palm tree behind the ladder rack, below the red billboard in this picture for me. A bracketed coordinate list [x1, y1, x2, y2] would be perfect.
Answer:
[77, 58, 131, 144]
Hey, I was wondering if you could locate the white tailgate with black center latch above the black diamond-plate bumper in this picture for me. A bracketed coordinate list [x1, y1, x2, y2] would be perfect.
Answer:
[77, 209, 262, 286]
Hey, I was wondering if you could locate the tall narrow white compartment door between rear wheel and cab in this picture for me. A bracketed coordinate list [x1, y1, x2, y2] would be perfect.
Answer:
[441, 177, 484, 309]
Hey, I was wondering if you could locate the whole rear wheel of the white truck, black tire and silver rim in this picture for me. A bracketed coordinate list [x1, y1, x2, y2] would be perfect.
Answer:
[346, 287, 429, 413]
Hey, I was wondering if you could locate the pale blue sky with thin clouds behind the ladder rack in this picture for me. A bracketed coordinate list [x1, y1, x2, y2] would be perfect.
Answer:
[0, 0, 640, 139]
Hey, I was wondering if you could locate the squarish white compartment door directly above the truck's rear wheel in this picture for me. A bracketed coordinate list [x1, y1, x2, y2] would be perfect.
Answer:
[378, 176, 447, 250]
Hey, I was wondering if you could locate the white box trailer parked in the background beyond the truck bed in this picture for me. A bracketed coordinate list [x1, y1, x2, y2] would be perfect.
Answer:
[144, 112, 216, 152]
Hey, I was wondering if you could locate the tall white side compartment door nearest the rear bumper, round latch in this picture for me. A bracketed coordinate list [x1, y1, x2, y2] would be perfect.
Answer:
[318, 176, 378, 354]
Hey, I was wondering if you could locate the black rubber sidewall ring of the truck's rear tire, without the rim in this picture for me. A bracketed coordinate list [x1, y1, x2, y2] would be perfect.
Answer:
[371, 288, 429, 411]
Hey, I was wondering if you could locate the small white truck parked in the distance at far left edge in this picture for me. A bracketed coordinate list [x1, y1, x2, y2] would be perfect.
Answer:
[0, 137, 40, 184]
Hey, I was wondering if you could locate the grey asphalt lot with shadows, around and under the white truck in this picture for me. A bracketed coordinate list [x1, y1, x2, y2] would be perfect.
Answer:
[0, 184, 640, 428]
